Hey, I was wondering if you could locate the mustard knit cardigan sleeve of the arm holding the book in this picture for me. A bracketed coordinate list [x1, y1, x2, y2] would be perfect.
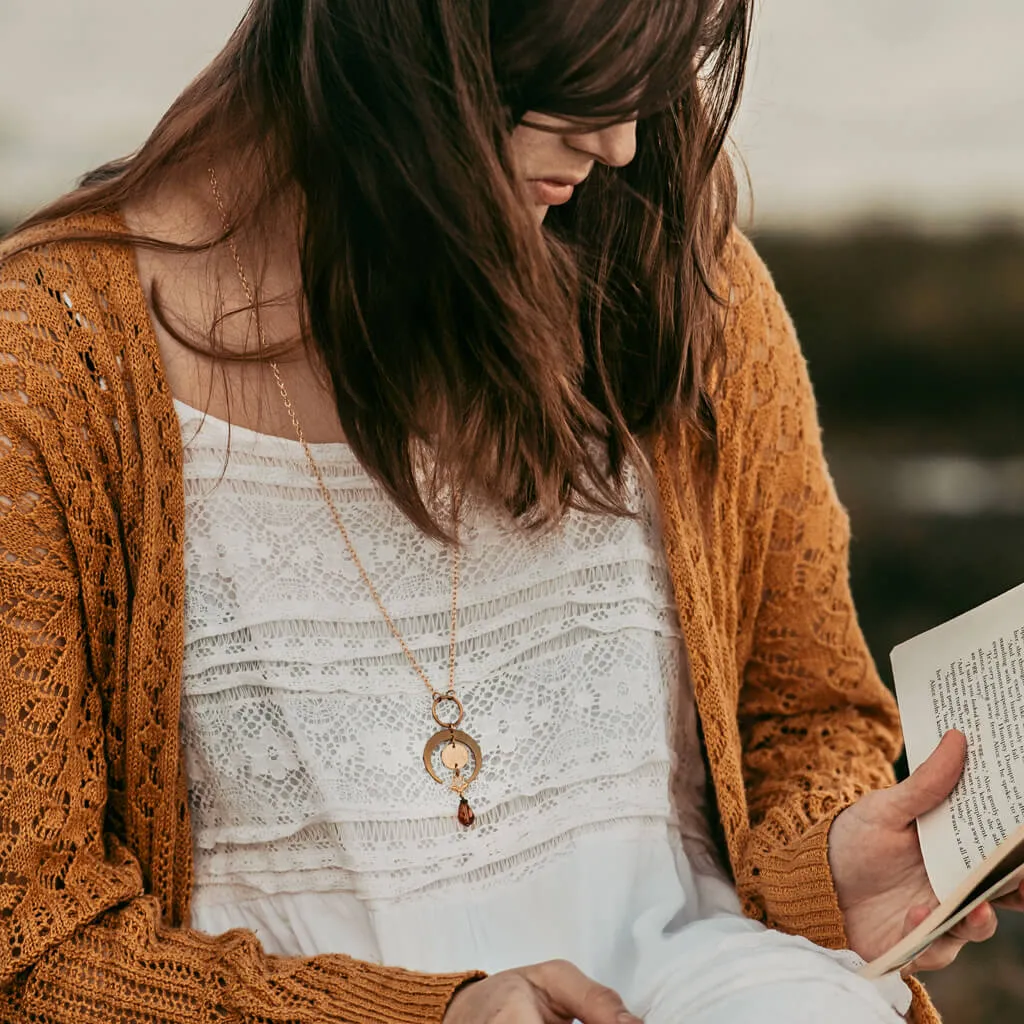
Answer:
[722, 238, 900, 947]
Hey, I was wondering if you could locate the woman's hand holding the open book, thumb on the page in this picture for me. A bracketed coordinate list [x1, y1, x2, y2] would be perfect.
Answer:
[828, 730, 1011, 973]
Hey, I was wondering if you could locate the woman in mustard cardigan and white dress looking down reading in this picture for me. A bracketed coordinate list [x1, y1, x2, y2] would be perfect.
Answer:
[0, 0, 994, 1024]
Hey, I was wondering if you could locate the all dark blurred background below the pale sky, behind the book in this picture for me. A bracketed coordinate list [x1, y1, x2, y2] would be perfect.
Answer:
[756, 229, 1024, 1024]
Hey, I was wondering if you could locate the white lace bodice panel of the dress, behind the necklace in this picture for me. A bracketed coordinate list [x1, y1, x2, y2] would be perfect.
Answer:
[179, 406, 720, 901]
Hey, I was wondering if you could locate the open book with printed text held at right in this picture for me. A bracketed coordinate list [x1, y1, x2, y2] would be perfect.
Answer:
[861, 585, 1024, 978]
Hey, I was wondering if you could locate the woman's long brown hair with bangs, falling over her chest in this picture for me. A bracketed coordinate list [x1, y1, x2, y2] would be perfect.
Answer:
[8, 0, 751, 536]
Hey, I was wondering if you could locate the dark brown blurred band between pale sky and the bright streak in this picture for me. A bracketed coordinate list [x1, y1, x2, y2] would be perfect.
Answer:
[757, 230, 1024, 456]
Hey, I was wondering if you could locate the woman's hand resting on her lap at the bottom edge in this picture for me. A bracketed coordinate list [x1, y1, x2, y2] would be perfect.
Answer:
[443, 961, 643, 1024]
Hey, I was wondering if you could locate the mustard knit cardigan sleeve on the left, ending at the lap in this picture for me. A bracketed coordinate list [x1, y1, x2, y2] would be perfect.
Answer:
[0, 243, 474, 1024]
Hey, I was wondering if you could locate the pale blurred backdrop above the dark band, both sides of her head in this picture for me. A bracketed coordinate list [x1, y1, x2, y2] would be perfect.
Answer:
[0, 0, 1024, 225]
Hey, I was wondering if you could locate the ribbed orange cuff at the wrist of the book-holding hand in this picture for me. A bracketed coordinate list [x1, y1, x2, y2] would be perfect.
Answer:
[753, 808, 846, 949]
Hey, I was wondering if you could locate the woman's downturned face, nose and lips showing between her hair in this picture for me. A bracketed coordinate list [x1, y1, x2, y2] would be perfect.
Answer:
[512, 114, 637, 222]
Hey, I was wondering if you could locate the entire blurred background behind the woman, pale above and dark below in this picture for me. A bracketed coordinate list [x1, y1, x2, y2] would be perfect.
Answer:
[0, 0, 1024, 1024]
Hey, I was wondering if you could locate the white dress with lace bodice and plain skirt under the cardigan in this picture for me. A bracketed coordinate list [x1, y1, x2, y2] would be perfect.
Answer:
[176, 402, 909, 1024]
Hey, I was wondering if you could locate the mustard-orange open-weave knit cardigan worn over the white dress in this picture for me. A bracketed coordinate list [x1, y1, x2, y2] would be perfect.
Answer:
[0, 215, 934, 1024]
